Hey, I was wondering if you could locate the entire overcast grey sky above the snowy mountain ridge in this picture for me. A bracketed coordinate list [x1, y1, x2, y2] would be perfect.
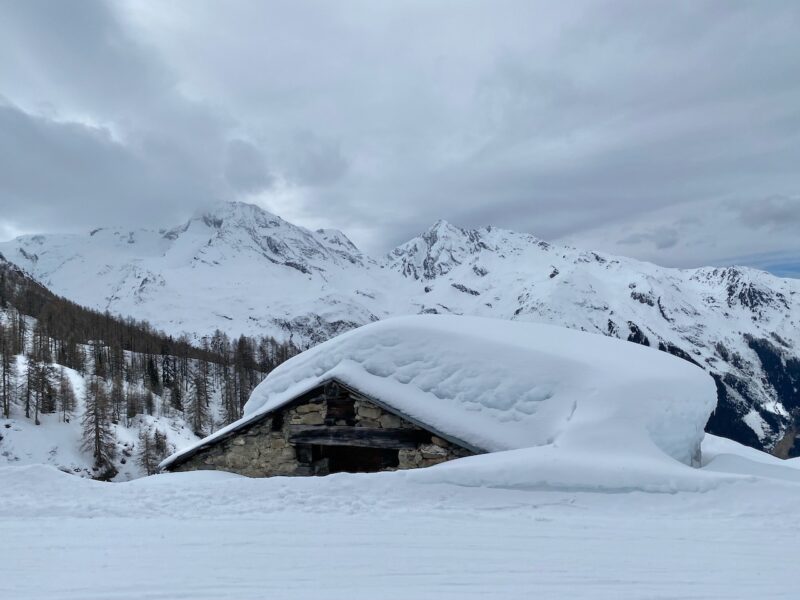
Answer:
[0, 0, 800, 273]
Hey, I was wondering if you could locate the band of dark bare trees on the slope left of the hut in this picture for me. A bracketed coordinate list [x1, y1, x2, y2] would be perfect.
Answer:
[0, 257, 299, 478]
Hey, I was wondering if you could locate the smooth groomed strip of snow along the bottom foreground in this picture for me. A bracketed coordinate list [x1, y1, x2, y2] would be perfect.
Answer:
[0, 510, 788, 600]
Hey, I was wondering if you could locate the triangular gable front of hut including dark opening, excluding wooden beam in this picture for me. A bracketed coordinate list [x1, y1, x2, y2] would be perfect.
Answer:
[169, 384, 474, 477]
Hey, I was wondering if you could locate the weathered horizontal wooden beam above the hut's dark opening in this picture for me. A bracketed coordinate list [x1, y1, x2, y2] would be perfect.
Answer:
[289, 425, 431, 449]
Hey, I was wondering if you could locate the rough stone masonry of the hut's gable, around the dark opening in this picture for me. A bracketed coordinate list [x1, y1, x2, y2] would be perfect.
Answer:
[169, 394, 473, 477]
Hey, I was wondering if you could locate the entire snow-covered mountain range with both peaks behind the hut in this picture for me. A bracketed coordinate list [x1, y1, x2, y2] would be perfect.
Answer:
[0, 203, 800, 454]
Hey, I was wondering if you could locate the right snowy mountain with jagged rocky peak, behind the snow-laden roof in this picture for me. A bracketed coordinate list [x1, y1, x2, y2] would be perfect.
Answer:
[387, 222, 800, 447]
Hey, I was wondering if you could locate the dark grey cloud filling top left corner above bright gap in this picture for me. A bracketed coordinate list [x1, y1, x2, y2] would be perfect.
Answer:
[0, 0, 174, 119]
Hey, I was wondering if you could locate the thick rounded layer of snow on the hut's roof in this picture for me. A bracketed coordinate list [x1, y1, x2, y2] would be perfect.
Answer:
[164, 315, 716, 465]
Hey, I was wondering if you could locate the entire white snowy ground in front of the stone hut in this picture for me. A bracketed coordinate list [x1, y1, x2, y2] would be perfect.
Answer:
[0, 438, 800, 600]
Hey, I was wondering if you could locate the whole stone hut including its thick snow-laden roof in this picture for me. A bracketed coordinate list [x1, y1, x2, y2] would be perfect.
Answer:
[161, 315, 716, 477]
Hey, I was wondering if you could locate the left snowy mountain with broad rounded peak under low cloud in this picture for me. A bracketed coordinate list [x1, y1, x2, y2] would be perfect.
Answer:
[0, 203, 412, 343]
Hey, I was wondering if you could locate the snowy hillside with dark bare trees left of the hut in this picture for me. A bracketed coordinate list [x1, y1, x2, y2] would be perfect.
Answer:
[0, 256, 295, 480]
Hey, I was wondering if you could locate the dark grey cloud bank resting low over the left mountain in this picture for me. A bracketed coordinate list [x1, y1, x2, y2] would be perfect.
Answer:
[0, 99, 219, 230]
